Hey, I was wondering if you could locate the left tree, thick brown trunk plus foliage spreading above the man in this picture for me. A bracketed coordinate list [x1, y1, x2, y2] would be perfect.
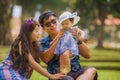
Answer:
[0, 0, 68, 45]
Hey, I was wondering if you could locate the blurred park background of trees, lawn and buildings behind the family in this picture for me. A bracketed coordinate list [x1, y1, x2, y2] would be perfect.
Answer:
[0, 0, 120, 80]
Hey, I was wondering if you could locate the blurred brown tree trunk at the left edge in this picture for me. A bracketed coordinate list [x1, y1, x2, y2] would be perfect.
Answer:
[0, 0, 14, 45]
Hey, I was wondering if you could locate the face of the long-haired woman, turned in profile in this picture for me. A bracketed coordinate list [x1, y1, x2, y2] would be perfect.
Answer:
[30, 25, 40, 42]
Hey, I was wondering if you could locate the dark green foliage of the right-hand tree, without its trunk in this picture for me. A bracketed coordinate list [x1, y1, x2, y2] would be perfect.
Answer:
[72, 0, 120, 26]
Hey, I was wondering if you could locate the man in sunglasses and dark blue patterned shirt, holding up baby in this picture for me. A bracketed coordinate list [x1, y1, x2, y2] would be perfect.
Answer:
[39, 11, 97, 80]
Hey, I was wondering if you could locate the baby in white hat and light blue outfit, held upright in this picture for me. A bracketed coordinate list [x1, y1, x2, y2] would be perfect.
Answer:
[55, 11, 84, 75]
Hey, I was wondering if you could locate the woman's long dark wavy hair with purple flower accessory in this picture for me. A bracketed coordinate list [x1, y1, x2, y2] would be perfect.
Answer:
[10, 19, 40, 70]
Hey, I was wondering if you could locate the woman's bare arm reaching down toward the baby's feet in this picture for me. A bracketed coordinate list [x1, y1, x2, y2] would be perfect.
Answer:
[28, 53, 63, 79]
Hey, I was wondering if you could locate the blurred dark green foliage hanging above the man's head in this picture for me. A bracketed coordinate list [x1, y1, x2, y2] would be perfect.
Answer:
[17, 0, 69, 15]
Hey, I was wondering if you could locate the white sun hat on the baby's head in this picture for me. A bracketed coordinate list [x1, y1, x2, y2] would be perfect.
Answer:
[59, 11, 80, 25]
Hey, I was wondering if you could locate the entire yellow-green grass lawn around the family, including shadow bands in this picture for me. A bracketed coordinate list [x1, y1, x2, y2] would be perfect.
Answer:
[0, 47, 120, 80]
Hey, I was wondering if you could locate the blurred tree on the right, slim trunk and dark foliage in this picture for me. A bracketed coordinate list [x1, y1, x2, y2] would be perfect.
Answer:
[73, 0, 120, 48]
